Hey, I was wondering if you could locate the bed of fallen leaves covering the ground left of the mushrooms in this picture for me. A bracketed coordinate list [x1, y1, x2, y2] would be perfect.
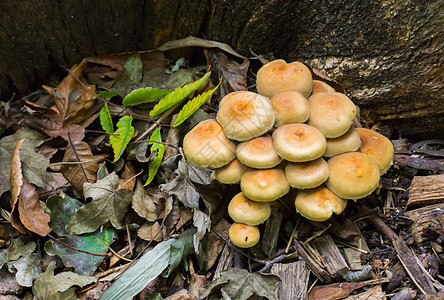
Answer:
[0, 37, 432, 299]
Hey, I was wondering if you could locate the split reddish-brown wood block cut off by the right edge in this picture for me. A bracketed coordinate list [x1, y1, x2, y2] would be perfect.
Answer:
[407, 174, 444, 206]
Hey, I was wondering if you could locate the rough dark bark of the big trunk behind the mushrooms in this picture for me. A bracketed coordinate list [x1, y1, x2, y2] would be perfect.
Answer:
[0, 0, 444, 137]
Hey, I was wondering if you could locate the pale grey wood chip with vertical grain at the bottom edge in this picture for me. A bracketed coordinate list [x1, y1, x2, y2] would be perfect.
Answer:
[271, 261, 310, 300]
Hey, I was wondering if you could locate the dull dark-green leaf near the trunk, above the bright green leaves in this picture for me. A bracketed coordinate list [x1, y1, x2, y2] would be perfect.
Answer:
[109, 53, 143, 98]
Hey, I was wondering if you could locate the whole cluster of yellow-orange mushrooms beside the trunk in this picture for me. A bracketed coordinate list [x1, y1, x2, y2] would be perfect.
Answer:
[183, 59, 394, 248]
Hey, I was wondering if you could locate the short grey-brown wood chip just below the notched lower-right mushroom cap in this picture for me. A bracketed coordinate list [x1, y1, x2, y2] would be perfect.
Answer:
[311, 233, 350, 278]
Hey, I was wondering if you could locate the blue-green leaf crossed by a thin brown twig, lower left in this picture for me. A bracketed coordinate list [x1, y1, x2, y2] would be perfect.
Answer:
[45, 227, 116, 275]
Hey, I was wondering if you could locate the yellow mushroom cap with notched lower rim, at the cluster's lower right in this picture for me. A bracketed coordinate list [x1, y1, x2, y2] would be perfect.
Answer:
[294, 185, 347, 222]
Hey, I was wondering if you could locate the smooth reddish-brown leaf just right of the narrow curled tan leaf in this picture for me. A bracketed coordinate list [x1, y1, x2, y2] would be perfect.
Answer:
[18, 178, 51, 236]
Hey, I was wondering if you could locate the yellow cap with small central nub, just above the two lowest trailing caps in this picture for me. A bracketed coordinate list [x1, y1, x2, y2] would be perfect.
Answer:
[240, 167, 290, 202]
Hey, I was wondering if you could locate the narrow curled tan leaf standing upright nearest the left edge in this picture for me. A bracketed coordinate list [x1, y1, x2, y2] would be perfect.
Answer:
[9, 138, 28, 233]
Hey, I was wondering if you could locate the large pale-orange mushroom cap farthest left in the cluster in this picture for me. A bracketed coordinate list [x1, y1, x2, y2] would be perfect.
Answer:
[183, 119, 236, 168]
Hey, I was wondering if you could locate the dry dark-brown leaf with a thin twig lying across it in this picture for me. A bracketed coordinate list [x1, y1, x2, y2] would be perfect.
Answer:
[60, 142, 103, 196]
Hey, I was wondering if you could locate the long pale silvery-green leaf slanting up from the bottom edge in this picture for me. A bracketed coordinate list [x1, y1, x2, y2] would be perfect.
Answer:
[100, 239, 176, 300]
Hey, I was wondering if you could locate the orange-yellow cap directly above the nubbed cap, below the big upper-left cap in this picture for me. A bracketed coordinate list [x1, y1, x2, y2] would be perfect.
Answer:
[236, 136, 282, 169]
